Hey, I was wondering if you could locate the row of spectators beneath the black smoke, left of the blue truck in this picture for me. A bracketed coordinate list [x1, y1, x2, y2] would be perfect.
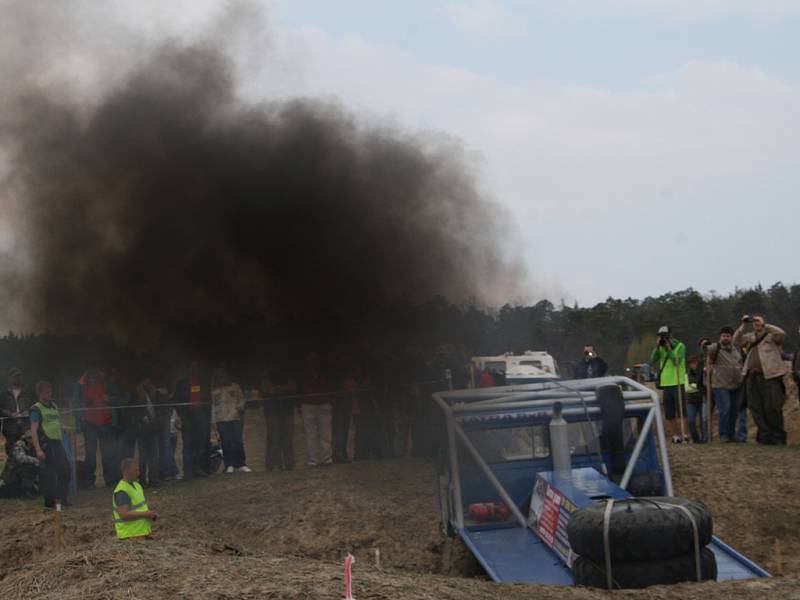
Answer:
[0, 344, 468, 506]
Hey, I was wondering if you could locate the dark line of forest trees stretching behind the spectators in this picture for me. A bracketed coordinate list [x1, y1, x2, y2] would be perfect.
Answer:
[0, 283, 800, 395]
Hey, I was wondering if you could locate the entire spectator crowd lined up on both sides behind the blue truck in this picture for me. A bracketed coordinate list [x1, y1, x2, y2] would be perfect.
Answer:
[0, 315, 800, 506]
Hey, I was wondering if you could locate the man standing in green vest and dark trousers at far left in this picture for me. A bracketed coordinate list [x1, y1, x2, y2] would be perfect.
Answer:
[30, 381, 70, 508]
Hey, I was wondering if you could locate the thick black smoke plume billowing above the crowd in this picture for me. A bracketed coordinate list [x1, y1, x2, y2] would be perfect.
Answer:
[0, 34, 517, 347]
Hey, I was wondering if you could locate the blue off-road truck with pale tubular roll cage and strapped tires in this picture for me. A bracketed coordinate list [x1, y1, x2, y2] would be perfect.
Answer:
[433, 377, 769, 587]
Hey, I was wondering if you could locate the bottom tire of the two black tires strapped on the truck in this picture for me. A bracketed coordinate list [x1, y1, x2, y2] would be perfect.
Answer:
[572, 548, 717, 589]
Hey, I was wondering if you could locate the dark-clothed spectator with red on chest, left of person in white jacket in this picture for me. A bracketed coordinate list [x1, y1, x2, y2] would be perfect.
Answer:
[174, 361, 211, 478]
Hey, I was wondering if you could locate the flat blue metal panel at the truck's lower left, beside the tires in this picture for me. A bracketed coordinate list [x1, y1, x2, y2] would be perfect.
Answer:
[458, 526, 574, 585]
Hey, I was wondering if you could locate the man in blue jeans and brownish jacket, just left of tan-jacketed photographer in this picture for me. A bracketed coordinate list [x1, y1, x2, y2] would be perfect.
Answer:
[705, 327, 747, 442]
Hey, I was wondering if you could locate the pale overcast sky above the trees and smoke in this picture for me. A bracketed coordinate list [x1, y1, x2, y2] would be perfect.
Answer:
[6, 0, 800, 305]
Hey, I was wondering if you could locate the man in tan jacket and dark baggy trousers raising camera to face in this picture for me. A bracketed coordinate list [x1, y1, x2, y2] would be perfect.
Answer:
[733, 315, 789, 444]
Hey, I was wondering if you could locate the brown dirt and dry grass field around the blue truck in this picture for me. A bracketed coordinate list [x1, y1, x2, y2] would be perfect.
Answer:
[0, 390, 800, 600]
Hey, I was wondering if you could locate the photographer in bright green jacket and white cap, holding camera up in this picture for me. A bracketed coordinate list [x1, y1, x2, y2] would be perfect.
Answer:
[650, 325, 689, 444]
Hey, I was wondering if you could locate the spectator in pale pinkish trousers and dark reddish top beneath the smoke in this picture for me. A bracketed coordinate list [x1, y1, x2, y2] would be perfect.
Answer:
[300, 352, 333, 467]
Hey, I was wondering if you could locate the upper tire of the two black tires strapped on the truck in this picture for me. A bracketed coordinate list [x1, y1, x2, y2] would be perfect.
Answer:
[567, 496, 713, 563]
